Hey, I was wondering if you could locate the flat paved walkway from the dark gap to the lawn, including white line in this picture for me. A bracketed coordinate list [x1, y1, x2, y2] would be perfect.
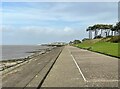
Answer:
[42, 46, 118, 87]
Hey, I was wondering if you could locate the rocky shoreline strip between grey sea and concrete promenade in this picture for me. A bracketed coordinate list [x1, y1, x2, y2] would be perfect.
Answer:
[0, 47, 55, 72]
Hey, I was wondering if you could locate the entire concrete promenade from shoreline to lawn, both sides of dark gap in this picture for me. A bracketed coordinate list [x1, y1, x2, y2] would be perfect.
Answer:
[2, 46, 119, 89]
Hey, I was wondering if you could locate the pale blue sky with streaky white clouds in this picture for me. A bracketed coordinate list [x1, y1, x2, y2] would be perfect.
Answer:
[0, 2, 118, 45]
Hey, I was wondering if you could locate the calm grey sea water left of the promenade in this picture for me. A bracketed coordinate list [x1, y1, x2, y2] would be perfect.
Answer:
[0, 45, 48, 60]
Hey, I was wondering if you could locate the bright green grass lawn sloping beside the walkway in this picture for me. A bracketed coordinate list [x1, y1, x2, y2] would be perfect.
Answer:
[74, 41, 120, 57]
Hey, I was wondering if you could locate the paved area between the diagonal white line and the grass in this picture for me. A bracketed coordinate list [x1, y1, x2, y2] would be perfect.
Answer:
[69, 47, 120, 87]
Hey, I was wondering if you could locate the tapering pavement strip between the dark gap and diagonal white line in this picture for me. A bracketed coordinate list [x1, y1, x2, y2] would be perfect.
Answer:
[42, 46, 85, 87]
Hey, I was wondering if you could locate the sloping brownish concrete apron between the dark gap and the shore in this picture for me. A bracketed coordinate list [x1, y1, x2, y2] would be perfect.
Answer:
[2, 47, 62, 89]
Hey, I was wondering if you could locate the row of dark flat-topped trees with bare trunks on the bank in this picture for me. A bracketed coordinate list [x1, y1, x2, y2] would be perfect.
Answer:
[86, 22, 120, 39]
